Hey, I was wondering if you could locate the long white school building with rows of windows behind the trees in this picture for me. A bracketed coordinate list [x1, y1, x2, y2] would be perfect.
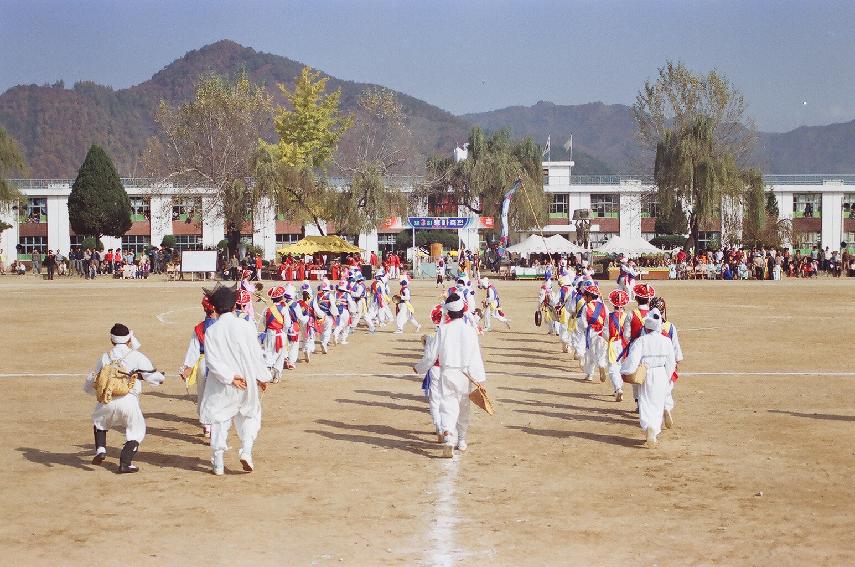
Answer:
[0, 161, 855, 263]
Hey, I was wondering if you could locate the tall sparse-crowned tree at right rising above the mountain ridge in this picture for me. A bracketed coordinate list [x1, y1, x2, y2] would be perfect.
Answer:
[633, 61, 762, 246]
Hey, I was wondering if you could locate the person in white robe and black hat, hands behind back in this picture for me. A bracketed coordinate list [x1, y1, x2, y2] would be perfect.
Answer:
[202, 287, 272, 475]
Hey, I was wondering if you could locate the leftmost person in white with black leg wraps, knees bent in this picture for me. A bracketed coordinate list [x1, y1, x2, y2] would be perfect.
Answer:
[83, 323, 164, 473]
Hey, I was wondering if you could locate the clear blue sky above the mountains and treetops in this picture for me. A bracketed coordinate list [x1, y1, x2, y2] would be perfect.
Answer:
[0, 0, 855, 131]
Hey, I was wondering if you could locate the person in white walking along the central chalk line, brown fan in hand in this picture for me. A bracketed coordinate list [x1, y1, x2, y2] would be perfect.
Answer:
[413, 294, 487, 458]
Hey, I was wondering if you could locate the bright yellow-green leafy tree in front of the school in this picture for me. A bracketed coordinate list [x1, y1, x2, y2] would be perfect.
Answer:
[255, 67, 353, 234]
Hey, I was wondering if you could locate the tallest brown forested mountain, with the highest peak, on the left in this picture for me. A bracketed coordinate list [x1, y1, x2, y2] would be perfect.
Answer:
[0, 40, 470, 177]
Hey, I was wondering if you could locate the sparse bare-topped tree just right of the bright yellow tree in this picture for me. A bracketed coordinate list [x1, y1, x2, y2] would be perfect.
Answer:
[330, 87, 414, 233]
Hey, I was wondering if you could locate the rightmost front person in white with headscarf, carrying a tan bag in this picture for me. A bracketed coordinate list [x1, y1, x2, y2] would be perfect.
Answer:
[621, 309, 676, 447]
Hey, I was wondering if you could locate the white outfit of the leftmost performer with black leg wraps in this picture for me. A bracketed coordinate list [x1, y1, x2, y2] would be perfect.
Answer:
[83, 345, 164, 443]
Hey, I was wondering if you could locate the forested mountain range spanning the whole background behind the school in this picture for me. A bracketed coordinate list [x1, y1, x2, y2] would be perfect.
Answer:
[0, 40, 855, 177]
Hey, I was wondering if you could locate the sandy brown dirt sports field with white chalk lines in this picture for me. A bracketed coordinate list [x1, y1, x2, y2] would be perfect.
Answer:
[0, 276, 855, 565]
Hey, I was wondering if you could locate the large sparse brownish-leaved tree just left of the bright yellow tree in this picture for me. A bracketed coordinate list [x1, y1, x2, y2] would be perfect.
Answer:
[145, 71, 272, 254]
